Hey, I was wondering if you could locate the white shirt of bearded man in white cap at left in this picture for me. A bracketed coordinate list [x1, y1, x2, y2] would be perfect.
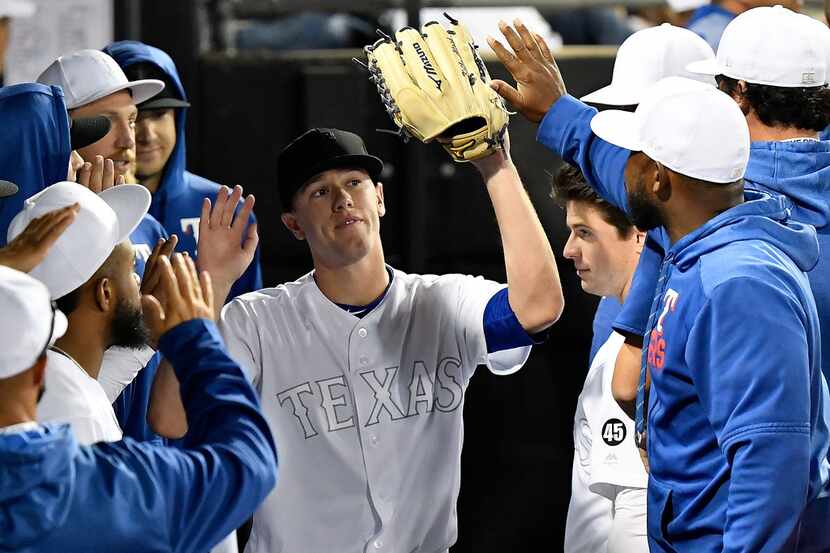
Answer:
[37, 350, 122, 445]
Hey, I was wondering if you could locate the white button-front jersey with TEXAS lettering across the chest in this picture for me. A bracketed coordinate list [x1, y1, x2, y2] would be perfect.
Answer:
[221, 271, 530, 553]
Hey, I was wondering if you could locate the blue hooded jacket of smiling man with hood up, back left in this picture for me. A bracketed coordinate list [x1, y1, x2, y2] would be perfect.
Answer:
[104, 40, 262, 301]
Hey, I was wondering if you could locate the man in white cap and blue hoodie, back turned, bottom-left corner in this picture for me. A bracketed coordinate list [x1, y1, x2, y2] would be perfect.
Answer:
[0, 252, 276, 553]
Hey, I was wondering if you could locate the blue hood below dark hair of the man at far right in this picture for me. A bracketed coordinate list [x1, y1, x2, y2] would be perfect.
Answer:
[744, 140, 830, 229]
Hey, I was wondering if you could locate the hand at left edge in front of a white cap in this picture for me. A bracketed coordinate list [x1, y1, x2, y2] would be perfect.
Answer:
[0, 203, 80, 273]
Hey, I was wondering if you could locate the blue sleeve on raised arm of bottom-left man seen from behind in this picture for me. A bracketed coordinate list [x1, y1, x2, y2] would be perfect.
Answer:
[152, 320, 277, 553]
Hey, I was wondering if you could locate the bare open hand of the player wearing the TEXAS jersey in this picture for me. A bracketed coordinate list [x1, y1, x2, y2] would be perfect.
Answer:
[196, 186, 259, 292]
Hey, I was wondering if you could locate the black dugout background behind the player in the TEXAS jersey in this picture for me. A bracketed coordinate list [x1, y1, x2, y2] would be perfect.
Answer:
[122, 0, 614, 553]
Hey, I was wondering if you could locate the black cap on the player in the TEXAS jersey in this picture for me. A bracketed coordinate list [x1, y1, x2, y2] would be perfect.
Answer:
[277, 128, 383, 212]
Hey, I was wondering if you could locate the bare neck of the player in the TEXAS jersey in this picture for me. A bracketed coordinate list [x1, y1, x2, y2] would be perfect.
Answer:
[314, 248, 389, 305]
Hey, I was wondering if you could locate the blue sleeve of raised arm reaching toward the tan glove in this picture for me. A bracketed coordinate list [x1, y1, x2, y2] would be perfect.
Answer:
[536, 95, 631, 213]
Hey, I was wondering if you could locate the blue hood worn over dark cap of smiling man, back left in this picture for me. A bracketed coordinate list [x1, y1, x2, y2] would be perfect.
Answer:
[104, 40, 187, 222]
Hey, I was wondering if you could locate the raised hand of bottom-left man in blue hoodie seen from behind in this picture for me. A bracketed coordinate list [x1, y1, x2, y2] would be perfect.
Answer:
[141, 253, 214, 336]
